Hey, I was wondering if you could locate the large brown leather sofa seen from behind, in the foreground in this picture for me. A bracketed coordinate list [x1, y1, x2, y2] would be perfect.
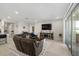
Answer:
[13, 35, 43, 56]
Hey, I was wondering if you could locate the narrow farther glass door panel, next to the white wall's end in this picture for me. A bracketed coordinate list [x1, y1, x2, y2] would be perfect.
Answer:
[65, 16, 71, 50]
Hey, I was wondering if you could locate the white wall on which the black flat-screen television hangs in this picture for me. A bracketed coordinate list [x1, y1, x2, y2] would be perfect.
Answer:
[30, 20, 63, 40]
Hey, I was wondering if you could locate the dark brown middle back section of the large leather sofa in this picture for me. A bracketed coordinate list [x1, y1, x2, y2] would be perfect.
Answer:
[21, 39, 35, 56]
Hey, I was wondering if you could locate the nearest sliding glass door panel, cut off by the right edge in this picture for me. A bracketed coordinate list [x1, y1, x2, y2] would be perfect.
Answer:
[72, 6, 79, 56]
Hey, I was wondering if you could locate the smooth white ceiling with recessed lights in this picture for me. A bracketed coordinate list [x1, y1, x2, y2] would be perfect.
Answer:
[0, 3, 70, 22]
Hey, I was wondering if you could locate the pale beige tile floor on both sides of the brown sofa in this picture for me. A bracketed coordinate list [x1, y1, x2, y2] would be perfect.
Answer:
[0, 38, 71, 56]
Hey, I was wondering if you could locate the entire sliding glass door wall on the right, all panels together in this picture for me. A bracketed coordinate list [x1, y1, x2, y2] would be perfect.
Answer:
[65, 5, 79, 56]
